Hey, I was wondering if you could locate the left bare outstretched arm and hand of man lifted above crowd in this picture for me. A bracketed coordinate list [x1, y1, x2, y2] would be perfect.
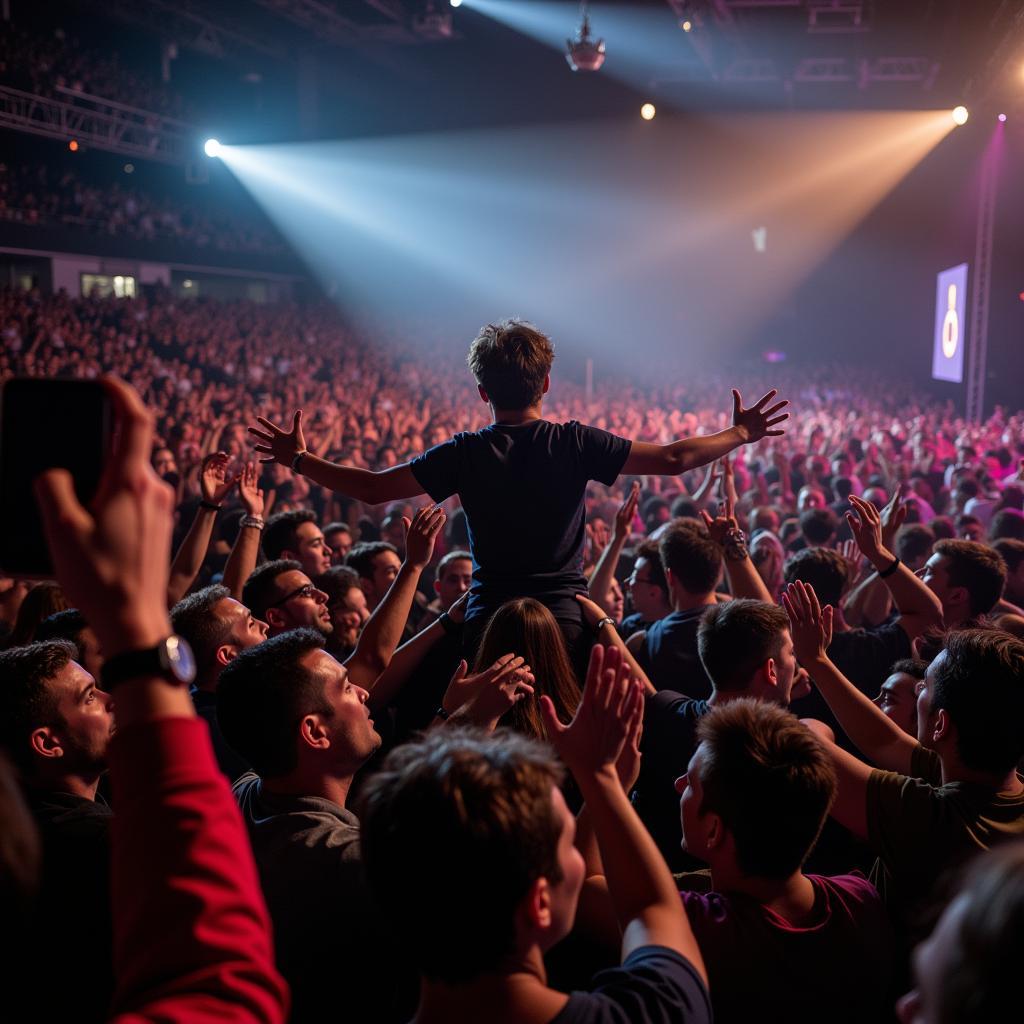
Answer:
[249, 409, 423, 505]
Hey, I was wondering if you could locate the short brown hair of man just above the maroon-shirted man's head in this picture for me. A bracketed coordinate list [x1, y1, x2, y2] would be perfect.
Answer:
[697, 598, 790, 690]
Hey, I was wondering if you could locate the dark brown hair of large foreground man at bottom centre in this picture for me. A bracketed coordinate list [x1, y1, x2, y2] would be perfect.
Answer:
[359, 729, 562, 984]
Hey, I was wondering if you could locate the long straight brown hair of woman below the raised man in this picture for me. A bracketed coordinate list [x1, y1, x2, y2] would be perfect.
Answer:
[473, 597, 581, 739]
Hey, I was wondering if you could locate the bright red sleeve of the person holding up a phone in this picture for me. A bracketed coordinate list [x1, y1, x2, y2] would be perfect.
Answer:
[111, 718, 288, 1024]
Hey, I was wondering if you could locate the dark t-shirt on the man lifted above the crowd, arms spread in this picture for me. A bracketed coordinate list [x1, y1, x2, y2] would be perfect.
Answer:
[410, 420, 632, 623]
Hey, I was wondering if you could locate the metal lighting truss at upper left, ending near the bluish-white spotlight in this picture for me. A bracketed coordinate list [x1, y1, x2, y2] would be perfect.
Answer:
[0, 86, 196, 164]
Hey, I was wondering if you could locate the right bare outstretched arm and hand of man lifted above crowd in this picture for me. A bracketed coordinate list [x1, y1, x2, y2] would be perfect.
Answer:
[618, 388, 790, 476]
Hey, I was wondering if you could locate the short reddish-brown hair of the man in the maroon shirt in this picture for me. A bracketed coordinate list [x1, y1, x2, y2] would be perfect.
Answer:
[697, 697, 836, 879]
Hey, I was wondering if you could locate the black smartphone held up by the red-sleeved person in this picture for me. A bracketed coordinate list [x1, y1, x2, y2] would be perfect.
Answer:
[0, 377, 114, 579]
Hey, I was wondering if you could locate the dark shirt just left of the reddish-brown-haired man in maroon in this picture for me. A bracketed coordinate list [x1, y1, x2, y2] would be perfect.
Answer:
[633, 690, 709, 871]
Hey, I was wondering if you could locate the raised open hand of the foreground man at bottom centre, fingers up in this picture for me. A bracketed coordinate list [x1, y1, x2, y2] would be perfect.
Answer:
[541, 644, 643, 781]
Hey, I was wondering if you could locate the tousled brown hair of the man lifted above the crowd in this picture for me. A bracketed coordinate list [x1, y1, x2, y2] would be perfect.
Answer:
[467, 319, 555, 410]
